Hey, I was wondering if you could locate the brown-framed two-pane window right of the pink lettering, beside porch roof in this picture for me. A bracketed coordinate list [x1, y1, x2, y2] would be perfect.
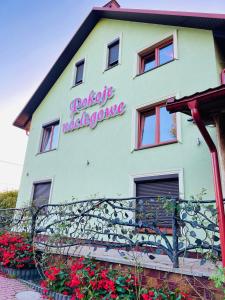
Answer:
[138, 104, 177, 148]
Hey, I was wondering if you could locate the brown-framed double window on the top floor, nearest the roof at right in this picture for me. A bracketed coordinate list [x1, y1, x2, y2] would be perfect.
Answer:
[139, 40, 174, 74]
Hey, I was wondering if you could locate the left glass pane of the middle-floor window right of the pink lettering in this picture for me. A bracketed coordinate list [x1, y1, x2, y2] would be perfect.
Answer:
[141, 112, 156, 146]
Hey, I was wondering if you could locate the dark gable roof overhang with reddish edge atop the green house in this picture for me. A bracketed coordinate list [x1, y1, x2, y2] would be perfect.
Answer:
[14, 7, 225, 129]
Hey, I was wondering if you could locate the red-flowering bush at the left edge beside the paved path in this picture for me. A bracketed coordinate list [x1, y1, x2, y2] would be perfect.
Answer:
[0, 232, 35, 269]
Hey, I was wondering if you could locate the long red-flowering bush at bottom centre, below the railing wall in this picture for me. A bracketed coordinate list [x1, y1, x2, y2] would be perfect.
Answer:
[41, 257, 191, 300]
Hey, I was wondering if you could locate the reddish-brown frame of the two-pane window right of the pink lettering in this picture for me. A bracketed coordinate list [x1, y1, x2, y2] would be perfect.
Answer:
[136, 101, 178, 150]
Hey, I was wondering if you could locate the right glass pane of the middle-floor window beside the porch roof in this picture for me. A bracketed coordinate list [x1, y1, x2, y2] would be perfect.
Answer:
[160, 106, 176, 142]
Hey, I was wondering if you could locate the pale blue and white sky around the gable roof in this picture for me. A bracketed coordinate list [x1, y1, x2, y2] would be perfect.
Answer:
[0, 0, 225, 191]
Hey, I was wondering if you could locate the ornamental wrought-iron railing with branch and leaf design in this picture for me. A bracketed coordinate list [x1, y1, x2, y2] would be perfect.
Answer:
[0, 197, 221, 268]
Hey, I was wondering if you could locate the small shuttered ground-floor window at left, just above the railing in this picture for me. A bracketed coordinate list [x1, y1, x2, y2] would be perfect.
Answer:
[32, 181, 51, 208]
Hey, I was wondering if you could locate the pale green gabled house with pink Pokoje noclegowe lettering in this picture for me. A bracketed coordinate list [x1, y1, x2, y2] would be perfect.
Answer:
[14, 1, 225, 220]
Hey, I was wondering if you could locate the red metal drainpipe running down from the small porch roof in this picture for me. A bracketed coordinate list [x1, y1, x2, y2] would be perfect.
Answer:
[188, 100, 225, 267]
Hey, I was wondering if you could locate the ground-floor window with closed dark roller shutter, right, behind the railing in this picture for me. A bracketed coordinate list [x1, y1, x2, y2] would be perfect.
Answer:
[135, 174, 179, 228]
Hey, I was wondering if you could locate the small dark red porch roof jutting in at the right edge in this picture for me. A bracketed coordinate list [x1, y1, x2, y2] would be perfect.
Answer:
[166, 84, 225, 124]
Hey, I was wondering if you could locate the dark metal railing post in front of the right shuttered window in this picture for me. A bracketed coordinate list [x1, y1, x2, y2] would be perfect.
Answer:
[172, 198, 179, 268]
